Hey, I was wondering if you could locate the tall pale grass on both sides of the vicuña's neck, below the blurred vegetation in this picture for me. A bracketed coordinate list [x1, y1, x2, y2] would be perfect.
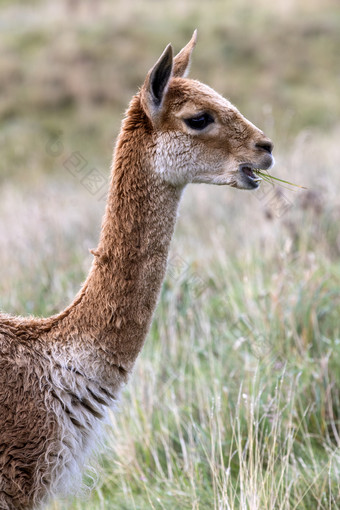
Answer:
[0, 139, 340, 510]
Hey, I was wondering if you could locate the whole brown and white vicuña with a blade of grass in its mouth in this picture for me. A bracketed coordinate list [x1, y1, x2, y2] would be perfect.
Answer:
[0, 33, 273, 510]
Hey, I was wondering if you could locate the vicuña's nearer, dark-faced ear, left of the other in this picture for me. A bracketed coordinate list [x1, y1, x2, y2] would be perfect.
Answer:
[141, 44, 173, 120]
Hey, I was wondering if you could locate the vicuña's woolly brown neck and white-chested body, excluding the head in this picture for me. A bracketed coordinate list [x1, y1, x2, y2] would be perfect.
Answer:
[0, 96, 181, 510]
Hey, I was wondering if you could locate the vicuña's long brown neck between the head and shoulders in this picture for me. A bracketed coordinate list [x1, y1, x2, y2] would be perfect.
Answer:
[56, 97, 181, 370]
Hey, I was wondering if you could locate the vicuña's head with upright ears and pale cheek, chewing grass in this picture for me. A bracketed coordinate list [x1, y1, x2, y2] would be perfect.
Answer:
[141, 31, 273, 189]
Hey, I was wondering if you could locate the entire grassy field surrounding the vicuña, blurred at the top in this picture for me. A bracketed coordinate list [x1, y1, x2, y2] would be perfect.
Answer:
[0, 0, 340, 510]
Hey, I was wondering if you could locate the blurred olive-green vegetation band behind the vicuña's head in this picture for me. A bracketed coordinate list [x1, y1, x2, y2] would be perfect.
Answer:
[0, 0, 340, 186]
